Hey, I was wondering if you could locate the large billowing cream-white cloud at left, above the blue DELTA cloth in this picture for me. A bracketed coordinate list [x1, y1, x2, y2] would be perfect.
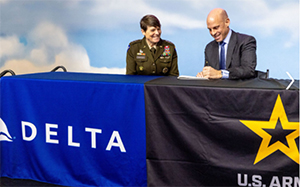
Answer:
[0, 23, 125, 74]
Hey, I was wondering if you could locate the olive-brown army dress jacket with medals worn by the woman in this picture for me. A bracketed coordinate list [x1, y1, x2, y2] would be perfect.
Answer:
[126, 37, 179, 76]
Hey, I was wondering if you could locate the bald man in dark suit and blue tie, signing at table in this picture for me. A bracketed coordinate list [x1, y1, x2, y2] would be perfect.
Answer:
[197, 8, 256, 79]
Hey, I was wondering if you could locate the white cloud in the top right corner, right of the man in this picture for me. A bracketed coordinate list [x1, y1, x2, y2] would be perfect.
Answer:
[234, 0, 299, 47]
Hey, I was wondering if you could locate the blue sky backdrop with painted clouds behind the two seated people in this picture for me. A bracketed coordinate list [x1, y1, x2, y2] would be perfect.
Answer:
[0, 0, 299, 79]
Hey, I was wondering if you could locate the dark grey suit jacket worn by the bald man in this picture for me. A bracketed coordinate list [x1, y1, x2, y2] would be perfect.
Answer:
[205, 31, 256, 79]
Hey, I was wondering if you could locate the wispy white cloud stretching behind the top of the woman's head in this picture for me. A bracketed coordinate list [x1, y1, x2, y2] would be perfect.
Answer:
[86, 0, 206, 29]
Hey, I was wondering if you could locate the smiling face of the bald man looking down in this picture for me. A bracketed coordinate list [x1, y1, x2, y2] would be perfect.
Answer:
[207, 16, 230, 42]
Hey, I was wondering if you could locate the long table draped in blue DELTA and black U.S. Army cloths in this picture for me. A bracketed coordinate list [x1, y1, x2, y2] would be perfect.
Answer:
[0, 72, 299, 186]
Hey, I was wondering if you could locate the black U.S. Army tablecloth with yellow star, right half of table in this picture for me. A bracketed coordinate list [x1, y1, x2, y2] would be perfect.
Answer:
[145, 77, 300, 187]
